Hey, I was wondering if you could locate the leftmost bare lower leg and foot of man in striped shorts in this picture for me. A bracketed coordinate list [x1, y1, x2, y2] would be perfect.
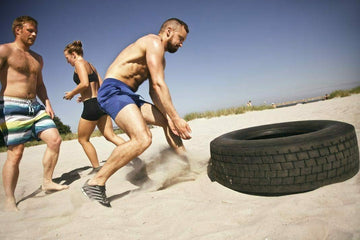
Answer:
[2, 144, 24, 211]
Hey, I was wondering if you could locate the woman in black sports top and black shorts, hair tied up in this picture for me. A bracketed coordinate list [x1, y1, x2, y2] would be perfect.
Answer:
[64, 41, 125, 172]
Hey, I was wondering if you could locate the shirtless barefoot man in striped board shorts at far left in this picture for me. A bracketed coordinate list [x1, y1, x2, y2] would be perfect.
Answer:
[0, 16, 68, 210]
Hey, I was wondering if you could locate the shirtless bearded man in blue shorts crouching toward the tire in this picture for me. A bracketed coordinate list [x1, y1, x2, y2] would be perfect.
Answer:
[82, 18, 191, 207]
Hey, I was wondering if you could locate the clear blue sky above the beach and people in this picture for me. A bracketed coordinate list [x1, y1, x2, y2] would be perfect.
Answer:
[0, 0, 360, 131]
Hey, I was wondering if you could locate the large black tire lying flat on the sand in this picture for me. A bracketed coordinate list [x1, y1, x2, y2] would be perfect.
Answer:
[208, 120, 359, 195]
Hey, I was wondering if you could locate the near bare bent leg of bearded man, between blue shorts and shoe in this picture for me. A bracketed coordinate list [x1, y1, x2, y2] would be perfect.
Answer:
[88, 104, 151, 186]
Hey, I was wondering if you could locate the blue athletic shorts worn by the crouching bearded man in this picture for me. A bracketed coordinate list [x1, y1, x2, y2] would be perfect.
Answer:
[97, 78, 147, 120]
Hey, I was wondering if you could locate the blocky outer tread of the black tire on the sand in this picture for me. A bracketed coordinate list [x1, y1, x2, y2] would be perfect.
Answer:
[209, 122, 359, 195]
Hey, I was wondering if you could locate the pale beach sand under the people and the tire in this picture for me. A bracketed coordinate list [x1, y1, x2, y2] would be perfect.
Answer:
[0, 94, 360, 240]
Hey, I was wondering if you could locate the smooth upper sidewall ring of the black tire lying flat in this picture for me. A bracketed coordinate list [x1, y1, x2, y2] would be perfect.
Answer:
[210, 120, 354, 154]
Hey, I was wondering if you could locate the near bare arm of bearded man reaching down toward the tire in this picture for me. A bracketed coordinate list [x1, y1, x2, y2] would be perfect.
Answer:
[146, 37, 191, 139]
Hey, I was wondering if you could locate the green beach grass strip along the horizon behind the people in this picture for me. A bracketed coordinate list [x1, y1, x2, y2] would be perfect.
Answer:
[0, 86, 360, 152]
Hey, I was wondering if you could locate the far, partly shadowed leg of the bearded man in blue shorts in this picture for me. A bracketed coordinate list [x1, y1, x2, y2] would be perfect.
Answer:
[141, 103, 185, 155]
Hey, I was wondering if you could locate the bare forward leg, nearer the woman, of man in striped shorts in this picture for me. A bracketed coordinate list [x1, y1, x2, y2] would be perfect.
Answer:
[39, 128, 69, 191]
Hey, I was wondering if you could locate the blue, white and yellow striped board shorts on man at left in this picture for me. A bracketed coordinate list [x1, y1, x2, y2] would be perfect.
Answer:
[0, 96, 56, 146]
